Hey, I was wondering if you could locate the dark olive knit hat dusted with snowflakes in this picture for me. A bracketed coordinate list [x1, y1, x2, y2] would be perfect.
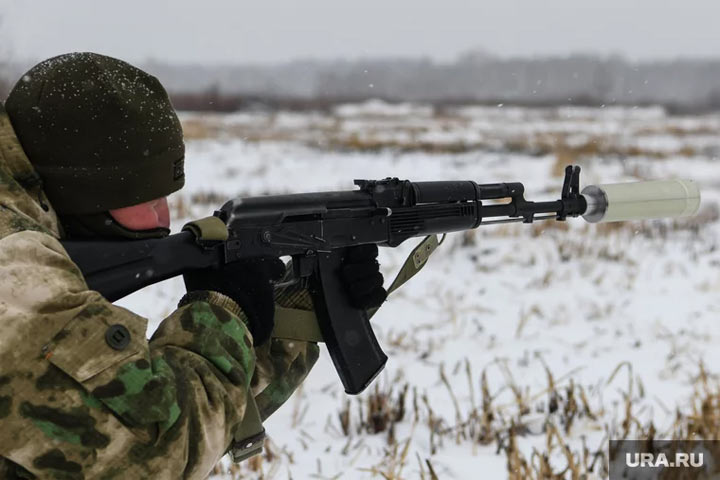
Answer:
[5, 53, 185, 214]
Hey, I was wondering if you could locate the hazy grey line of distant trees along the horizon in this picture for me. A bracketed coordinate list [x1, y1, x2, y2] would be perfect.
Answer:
[142, 50, 720, 110]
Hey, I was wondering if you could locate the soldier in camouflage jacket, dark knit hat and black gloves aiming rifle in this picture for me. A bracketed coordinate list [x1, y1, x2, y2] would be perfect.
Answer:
[0, 53, 386, 479]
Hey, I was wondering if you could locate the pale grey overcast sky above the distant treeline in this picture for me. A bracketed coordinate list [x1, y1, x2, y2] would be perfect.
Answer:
[0, 0, 720, 63]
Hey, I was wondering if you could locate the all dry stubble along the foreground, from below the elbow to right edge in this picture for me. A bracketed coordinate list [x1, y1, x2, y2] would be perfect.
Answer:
[207, 357, 720, 480]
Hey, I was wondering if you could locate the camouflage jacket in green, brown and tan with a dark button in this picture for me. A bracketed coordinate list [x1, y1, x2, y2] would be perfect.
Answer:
[0, 106, 318, 479]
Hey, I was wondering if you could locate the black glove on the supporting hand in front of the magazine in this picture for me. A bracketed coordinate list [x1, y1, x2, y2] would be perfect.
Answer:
[340, 244, 387, 310]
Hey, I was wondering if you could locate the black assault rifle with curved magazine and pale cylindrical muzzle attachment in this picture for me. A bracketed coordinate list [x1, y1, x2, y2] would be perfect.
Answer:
[63, 166, 700, 394]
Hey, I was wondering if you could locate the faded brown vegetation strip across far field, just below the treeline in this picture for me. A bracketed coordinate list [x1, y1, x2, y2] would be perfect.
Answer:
[177, 110, 718, 159]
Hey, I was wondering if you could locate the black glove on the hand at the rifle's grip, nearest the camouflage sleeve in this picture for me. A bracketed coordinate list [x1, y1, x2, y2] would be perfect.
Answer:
[183, 257, 285, 345]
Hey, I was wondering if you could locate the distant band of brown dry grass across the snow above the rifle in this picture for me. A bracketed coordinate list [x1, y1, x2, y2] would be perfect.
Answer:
[183, 112, 704, 159]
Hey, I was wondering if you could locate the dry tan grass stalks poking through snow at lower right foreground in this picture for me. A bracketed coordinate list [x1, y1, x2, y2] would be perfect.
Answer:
[310, 359, 720, 480]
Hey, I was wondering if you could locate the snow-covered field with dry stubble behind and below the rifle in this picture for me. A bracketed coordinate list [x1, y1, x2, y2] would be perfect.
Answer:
[115, 101, 720, 479]
